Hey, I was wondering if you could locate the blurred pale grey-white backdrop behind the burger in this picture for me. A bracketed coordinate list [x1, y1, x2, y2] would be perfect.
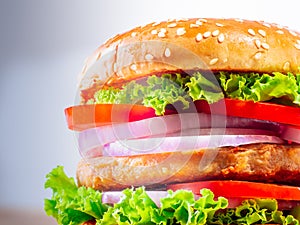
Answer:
[0, 0, 300, 208]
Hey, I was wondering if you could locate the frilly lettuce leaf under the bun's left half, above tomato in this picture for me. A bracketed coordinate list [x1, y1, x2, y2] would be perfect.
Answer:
[89, 72, 224, 115]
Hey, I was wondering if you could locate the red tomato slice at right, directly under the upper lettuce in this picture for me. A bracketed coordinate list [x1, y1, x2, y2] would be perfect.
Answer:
[195, 99, 300, 126]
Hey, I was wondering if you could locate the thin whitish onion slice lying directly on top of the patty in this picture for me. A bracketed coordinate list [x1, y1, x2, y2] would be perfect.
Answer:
[102, 135, 283, 156]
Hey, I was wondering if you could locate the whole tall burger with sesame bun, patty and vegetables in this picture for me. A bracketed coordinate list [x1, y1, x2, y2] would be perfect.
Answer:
[45, 18, 300, 225]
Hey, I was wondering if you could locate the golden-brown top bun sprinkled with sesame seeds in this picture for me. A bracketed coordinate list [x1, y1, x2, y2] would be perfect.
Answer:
[80, 18, 300, 90]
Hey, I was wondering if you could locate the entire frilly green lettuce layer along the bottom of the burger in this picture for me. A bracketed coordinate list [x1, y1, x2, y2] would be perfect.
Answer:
[44, 166, 299, 225]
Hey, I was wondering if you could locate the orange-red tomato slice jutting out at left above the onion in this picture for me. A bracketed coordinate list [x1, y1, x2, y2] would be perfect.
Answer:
[65, 104, 175, 131]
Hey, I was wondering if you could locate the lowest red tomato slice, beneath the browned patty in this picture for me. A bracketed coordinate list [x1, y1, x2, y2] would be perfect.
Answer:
[167, 180, 300, 201]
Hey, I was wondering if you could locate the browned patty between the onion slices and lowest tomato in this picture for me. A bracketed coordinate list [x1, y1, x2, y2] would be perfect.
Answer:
[77, 144, 300, 191]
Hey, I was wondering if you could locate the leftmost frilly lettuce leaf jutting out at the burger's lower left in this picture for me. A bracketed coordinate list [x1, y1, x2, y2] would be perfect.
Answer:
[44, 166, 108, 225]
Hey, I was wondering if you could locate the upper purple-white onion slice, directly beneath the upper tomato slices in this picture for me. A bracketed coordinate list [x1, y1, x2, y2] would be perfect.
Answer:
[78, 113, 279, 156]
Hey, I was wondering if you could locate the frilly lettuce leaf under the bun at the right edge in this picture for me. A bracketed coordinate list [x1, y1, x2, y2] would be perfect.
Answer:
[220, 72, 300, 104]
